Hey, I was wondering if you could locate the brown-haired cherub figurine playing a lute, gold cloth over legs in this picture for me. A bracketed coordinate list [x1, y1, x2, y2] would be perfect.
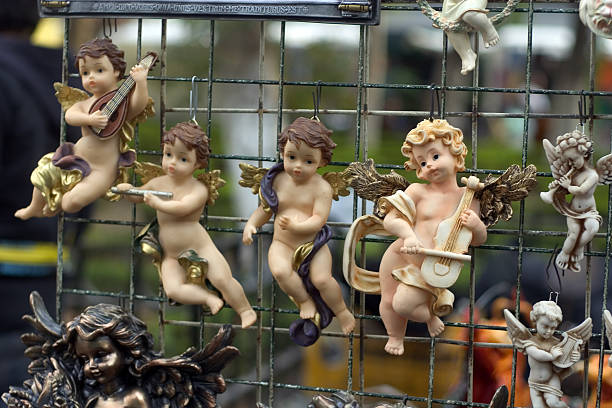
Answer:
[15, 38, 154, 220]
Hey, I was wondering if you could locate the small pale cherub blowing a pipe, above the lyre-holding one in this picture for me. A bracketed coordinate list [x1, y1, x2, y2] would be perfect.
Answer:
[540, 130, 612, 272]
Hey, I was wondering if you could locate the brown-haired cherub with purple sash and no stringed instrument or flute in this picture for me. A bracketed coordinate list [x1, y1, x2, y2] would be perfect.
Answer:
[240, 117, 355, 346]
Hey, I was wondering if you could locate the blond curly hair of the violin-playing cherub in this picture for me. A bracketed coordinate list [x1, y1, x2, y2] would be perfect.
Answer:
[402, 119, 467, 176]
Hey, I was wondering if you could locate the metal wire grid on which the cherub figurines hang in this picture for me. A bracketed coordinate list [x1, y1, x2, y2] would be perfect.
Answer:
[50, 0, 612, 408]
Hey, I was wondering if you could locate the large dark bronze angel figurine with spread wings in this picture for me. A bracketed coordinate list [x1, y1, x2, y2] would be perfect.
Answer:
[2, 292, 239, 408]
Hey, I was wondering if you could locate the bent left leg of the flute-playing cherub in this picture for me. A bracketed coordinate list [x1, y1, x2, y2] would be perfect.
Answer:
[161, 257, 223, 314]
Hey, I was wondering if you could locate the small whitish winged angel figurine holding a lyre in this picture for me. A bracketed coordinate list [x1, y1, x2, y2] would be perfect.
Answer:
[504, 300, 593, 408]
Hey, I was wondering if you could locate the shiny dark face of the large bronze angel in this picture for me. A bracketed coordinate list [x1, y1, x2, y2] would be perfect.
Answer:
[75, 336, 125, 385]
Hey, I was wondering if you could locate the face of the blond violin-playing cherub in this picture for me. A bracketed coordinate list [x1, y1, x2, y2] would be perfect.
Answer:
[412, 139, 457, 183]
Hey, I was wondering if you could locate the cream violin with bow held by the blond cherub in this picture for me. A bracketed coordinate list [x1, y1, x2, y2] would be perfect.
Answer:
[419, 176, 484, 288]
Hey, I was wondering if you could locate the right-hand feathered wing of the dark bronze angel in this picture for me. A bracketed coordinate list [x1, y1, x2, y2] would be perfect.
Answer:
[141, 324, 240, 408]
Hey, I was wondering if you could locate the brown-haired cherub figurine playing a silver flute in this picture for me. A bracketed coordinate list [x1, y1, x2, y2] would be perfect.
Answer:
[117, 122, 257, 328]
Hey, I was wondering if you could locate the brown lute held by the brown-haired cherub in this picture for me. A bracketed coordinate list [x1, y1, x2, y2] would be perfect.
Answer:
[89, 52, 157, 138]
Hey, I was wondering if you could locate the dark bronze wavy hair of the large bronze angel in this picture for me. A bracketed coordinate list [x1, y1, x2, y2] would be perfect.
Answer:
[62, 303, 159, 376]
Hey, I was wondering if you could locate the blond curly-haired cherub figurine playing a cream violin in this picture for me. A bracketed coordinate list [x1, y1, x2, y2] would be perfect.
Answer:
[343, 119, 536, 355]
